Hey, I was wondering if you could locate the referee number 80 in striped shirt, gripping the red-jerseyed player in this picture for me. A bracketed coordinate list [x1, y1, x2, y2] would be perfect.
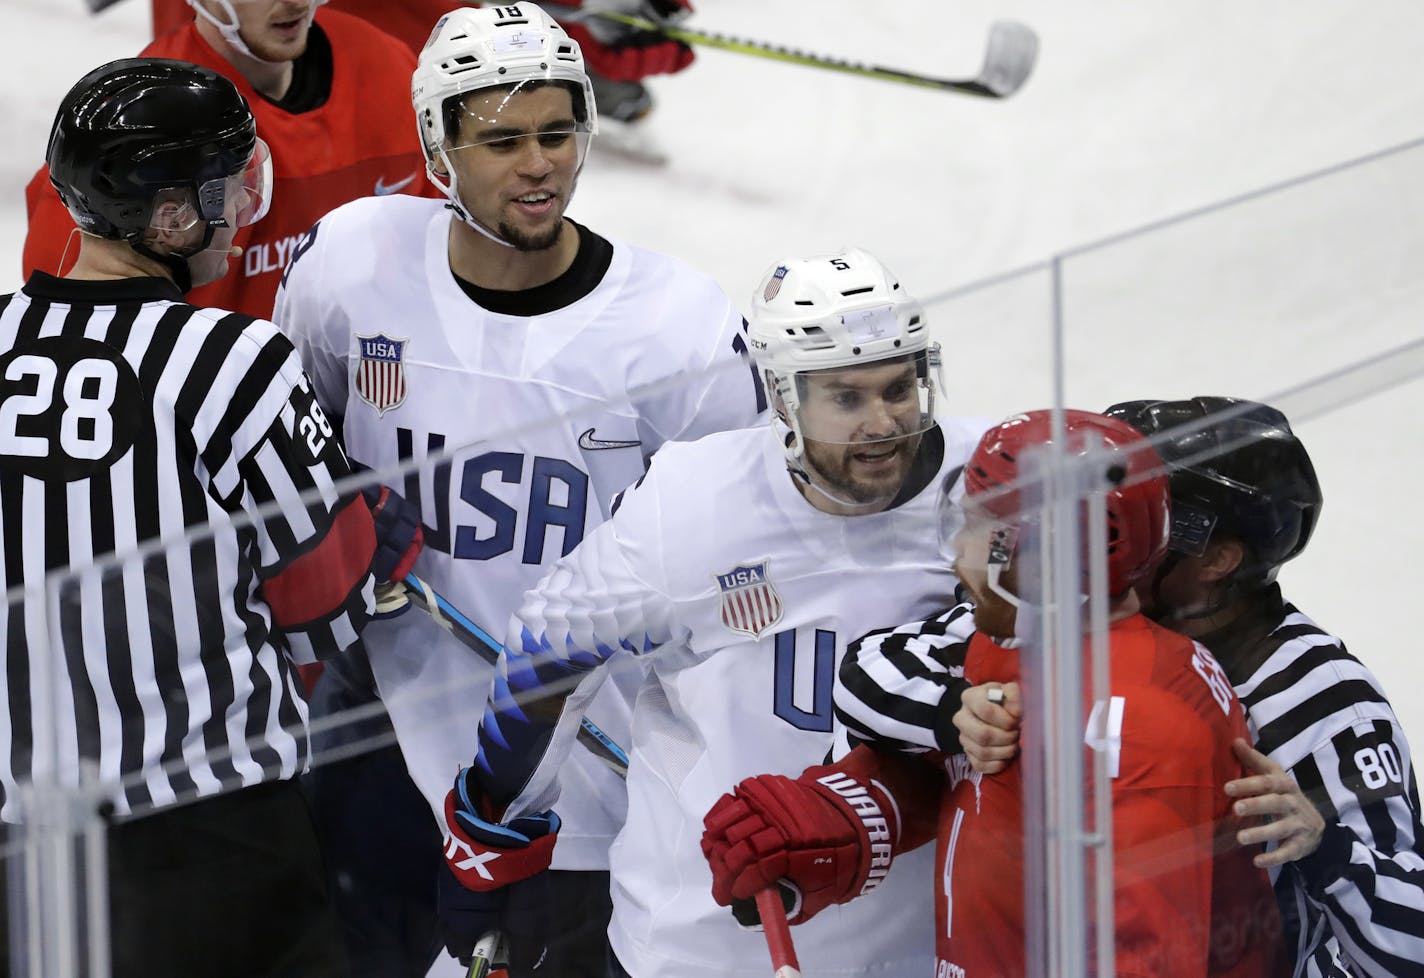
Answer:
[834, 397, 1424, 978]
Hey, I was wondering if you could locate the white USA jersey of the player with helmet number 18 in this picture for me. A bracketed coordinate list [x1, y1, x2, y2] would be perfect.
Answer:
[273, 195, 759, 870]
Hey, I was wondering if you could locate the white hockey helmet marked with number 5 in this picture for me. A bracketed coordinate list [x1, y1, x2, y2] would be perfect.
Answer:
[748, 248, 934, 471]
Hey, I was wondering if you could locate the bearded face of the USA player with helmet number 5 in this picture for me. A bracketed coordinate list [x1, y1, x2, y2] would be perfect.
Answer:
[799, 362, 924, 504]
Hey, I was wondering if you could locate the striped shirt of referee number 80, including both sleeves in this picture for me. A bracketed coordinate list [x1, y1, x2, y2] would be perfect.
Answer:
[834, 585, 1424, 978]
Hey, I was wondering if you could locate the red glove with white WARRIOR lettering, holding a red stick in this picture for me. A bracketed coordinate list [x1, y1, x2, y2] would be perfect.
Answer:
[702, 767, 900, 924]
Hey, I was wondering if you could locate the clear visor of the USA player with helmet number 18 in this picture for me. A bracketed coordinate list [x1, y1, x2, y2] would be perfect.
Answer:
[441, 78, 595, 171]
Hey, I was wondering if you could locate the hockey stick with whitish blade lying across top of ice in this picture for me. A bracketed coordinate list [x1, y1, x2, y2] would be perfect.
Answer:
[570, 10, 1038, 98]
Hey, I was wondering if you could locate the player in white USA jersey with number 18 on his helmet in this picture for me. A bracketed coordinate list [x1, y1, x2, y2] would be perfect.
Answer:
[275, 3, 765, 974]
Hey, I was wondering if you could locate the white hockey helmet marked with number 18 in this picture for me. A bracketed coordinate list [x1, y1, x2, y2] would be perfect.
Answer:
[410, 3, 598, 227]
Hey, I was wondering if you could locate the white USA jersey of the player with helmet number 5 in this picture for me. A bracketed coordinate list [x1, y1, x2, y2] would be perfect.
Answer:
[476, 420, 985, 978]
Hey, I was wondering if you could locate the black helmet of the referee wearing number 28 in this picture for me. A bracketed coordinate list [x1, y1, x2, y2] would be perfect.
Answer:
[44, 58, 265, 251]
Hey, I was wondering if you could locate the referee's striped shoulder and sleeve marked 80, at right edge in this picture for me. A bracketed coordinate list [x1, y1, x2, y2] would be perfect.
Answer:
[1200, 585, 1424, 978]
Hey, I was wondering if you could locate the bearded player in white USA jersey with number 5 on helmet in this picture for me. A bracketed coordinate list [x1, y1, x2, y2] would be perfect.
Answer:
[446, 249, 985, 978]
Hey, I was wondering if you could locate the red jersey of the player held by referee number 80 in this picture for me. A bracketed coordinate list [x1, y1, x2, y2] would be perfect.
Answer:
[836, 615, 1289, 978]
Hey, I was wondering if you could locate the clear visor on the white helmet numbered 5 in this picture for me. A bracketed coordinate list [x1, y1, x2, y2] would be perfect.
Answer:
[786, 350, 934, 444]
